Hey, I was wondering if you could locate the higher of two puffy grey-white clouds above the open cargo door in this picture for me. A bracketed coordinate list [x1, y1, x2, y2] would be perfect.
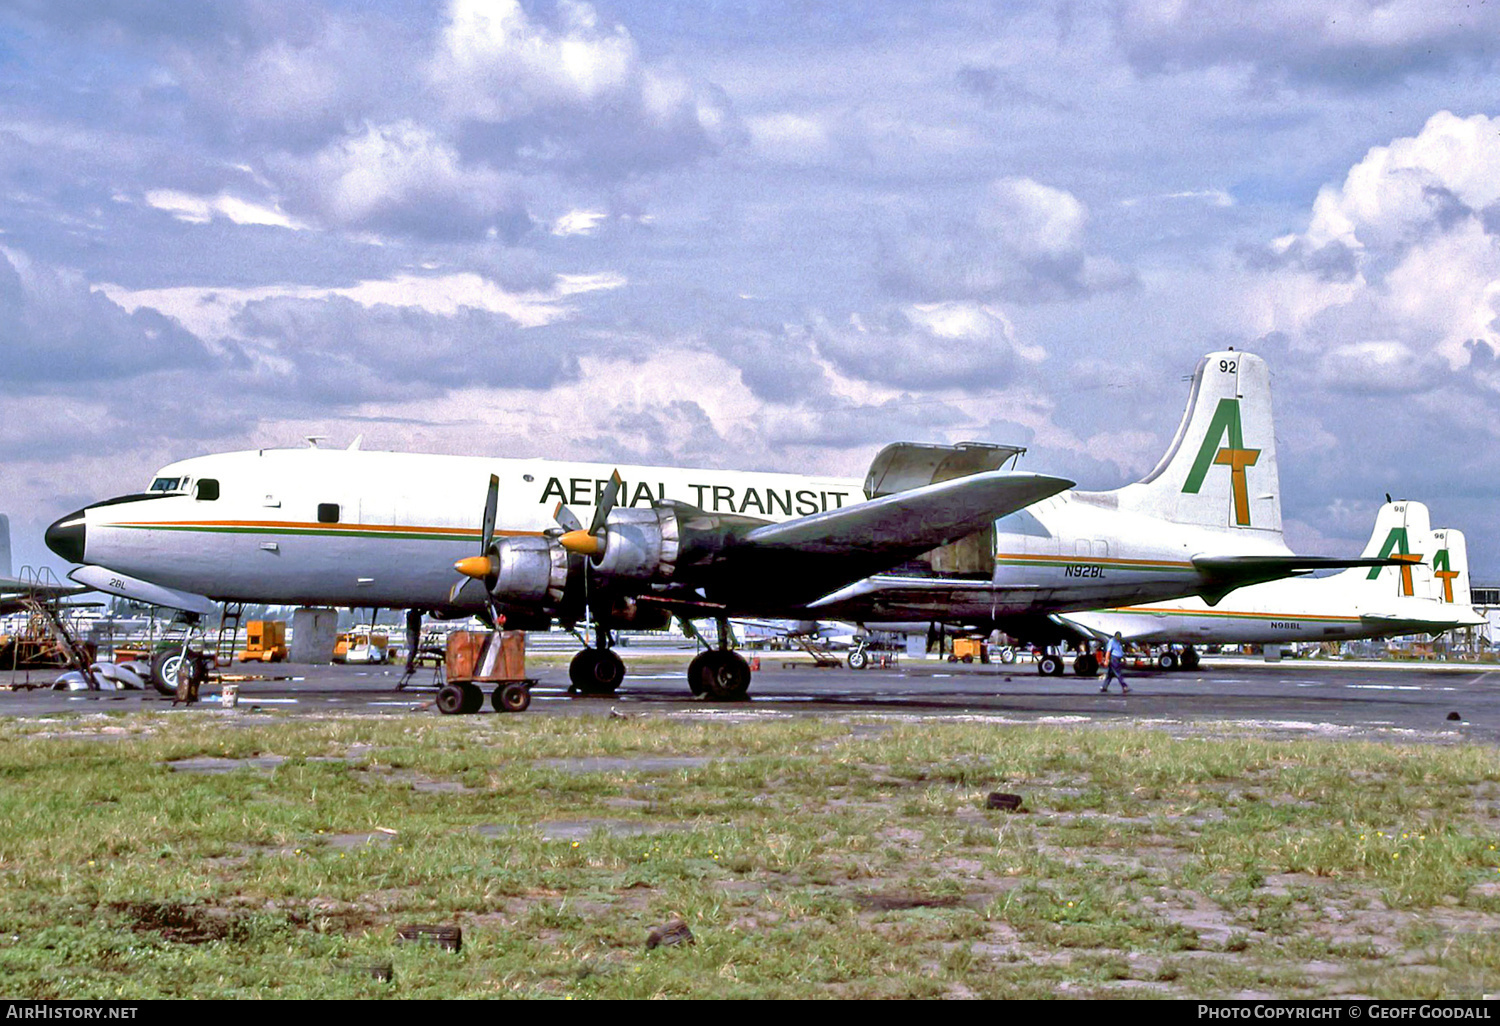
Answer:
[882, 179, 1134, 303]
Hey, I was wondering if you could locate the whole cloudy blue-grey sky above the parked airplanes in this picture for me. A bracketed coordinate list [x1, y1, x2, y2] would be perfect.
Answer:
[0, 0, 1500, 581]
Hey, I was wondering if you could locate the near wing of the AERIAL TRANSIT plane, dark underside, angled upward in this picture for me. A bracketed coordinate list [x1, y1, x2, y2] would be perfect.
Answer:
[714, 471, 1073, 606]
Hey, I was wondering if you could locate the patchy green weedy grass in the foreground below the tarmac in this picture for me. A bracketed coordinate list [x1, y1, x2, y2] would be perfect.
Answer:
[0, 711, 1500, 999]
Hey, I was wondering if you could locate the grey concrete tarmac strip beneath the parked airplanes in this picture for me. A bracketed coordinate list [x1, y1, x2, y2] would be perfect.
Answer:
[0, 650, 1500, 744]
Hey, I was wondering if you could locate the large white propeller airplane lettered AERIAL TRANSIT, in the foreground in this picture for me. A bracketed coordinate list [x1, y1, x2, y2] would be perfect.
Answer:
[47, 351, 1389, 698]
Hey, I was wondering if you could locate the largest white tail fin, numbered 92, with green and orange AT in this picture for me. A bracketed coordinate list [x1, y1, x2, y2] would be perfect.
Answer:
[1115, 350, 1281, 540]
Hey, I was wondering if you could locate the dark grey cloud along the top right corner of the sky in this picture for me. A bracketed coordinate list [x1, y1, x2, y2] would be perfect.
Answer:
[1115, 0, 1500, 84]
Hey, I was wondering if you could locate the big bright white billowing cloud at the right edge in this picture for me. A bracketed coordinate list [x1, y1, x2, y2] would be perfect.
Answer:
[1247, 111, 1500, 370]
